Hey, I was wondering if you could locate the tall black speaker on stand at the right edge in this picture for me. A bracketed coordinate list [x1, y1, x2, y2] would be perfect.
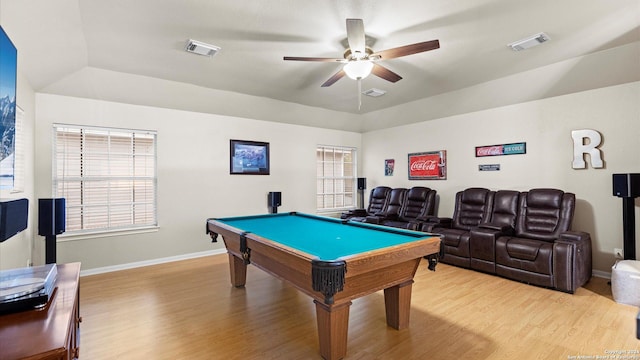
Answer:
[613, 174, 640, 260]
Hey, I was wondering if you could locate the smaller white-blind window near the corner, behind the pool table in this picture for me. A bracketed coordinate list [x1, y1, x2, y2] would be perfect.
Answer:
[316, 145, 357, 211]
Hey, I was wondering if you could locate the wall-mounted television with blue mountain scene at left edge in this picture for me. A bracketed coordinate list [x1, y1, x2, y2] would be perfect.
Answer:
[0, 26, 18, 189]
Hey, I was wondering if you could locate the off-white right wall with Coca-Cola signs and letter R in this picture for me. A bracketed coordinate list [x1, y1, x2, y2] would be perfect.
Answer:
[362, 82, 640, 272]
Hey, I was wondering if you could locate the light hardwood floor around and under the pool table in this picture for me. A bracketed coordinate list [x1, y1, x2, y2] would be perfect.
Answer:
[80, 255, 640, 360]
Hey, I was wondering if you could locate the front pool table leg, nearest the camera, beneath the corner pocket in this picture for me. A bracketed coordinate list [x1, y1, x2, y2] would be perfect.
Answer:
[313, 300, 351, 360]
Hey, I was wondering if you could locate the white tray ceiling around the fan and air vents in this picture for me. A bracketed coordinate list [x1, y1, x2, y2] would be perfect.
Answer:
[0, 0, 640, 131]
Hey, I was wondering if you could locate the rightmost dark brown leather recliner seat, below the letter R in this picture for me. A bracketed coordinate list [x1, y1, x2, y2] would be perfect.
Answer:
[495, 189, 592, 293]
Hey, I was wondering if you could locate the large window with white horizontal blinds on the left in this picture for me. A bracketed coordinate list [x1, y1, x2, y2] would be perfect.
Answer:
[53, 125, 157, 233]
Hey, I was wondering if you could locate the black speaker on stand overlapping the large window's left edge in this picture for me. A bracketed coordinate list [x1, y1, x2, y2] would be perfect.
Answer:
[38, 198, 67, 264]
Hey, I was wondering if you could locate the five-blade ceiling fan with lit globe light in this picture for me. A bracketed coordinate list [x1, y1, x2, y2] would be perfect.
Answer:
[284, 19, 440, 87]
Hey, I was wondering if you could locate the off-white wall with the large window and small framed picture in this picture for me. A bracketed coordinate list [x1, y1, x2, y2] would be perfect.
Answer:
[36, 94, 362, 270]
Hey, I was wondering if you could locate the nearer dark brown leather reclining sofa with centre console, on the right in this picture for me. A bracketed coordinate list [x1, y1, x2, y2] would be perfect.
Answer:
[421, 188, 592, 293]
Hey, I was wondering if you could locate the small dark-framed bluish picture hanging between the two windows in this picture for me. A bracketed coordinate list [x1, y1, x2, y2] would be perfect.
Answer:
[229, 140, 269, 175]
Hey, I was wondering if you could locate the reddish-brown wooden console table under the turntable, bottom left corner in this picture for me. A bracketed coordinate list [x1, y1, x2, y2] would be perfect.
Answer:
[0, 263, 82, 360]
